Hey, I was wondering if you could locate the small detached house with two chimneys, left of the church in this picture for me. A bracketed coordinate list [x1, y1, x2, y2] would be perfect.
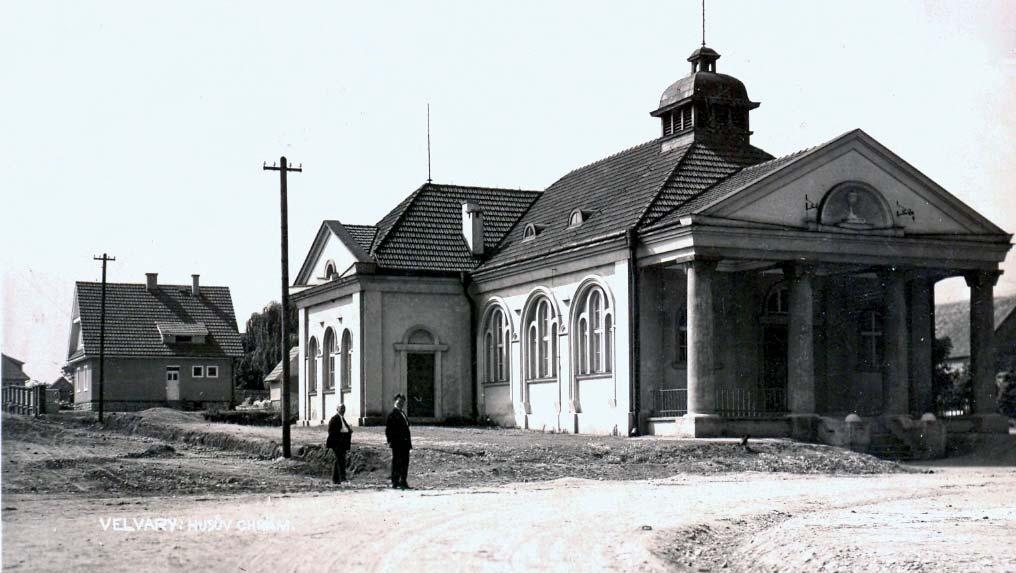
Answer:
[65, 272, 243, 410]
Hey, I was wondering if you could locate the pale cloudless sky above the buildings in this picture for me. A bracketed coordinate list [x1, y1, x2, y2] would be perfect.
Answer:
[0, 0, 1016, 381]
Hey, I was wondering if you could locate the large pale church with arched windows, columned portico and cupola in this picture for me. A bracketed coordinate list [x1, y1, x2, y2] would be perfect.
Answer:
[292, 42, 1011, 436]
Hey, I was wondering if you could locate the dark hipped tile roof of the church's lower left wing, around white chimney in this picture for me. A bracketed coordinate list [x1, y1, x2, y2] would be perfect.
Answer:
[371, 183, 539, 271]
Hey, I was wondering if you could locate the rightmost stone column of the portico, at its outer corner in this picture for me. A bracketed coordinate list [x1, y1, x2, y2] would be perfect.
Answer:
[966, 271, 999, 415]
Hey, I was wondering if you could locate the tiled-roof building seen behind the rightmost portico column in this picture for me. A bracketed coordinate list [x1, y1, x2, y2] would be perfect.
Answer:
[935, 296, 1016, 370]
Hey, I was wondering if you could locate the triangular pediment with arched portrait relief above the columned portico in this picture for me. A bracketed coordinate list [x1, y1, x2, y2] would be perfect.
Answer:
[694, 130, 1006, 236]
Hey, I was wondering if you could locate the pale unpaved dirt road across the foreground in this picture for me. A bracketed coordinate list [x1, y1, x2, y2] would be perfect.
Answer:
[3, 468, 1016, 571]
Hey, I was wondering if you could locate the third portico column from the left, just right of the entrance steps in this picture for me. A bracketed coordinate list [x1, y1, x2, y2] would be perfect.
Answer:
[882, 269, 910, 416]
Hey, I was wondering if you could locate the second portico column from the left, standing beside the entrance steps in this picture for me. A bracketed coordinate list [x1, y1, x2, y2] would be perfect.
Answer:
[784, 265, 815, 413]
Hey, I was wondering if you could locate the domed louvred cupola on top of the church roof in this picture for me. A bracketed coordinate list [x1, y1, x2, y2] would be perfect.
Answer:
[650, 46, 759, 149]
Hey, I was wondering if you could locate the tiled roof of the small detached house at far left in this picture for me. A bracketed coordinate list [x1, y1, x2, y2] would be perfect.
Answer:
[75, 281, 243, 357]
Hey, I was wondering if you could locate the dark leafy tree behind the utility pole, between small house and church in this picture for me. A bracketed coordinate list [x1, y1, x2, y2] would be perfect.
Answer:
[237, 301, 299, 390]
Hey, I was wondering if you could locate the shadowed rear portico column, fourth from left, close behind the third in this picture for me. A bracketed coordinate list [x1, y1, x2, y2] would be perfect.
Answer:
[907, 276, 935, 415]
